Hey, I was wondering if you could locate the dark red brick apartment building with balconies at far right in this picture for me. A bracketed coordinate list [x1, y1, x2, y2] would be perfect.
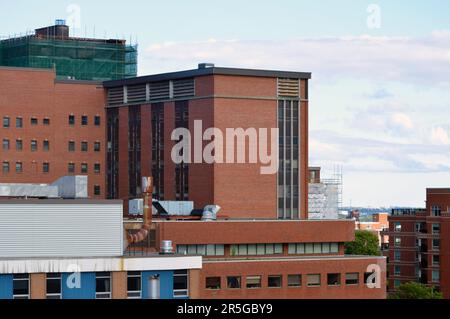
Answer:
[384, 189, 450, 298]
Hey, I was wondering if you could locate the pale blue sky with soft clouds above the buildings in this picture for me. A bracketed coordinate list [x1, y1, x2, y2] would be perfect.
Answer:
[0, 0, 450, 207]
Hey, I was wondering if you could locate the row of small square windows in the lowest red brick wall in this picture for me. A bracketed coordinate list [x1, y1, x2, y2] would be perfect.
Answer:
[205, 273, 372, 290]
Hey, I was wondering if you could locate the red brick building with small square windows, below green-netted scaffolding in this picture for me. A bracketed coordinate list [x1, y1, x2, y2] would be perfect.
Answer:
[0, 67, 106, 198]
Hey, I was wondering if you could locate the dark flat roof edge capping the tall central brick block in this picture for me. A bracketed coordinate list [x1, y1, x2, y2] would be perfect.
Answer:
[103, 67, 311, 88]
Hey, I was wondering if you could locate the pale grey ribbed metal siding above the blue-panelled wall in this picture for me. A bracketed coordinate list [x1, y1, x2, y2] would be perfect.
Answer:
[0, 204, 123, 258]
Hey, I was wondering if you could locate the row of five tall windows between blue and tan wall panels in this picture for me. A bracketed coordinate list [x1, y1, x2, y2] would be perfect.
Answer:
[13, 270, 189, 299]
